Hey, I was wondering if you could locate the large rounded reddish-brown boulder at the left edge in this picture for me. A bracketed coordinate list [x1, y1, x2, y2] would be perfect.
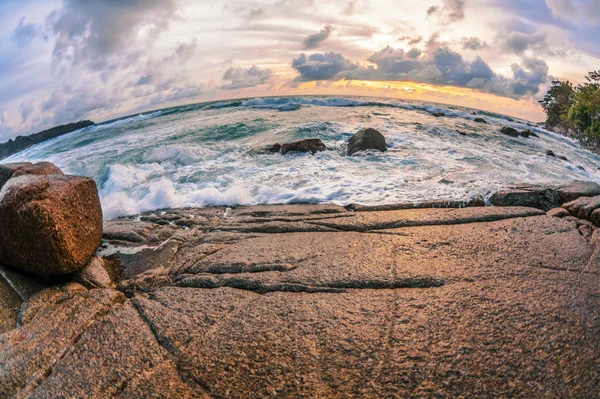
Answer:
[0, 175, 102, 276]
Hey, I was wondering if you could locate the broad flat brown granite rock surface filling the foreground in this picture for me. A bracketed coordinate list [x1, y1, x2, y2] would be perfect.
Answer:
[0, 205, 600, 398]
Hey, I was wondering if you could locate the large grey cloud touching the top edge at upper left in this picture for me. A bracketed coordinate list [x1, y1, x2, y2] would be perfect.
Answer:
[48, 0, 175, 70]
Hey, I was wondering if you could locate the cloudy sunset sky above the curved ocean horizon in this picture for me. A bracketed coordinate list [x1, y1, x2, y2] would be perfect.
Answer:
[0, 0, 600, 141]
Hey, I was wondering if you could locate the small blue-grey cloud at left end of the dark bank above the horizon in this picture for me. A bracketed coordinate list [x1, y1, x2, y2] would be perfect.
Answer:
[292, 51, 358, 82]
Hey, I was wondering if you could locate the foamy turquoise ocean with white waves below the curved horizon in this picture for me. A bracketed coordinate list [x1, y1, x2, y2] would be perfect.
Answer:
[3, 96, 600, 219]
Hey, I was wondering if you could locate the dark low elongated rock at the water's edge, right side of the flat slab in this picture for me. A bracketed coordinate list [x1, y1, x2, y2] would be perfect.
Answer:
[490, 187, 562, 212]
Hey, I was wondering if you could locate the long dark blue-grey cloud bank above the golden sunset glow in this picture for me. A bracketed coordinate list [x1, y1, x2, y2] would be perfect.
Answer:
[292, 44, 549, 98]
